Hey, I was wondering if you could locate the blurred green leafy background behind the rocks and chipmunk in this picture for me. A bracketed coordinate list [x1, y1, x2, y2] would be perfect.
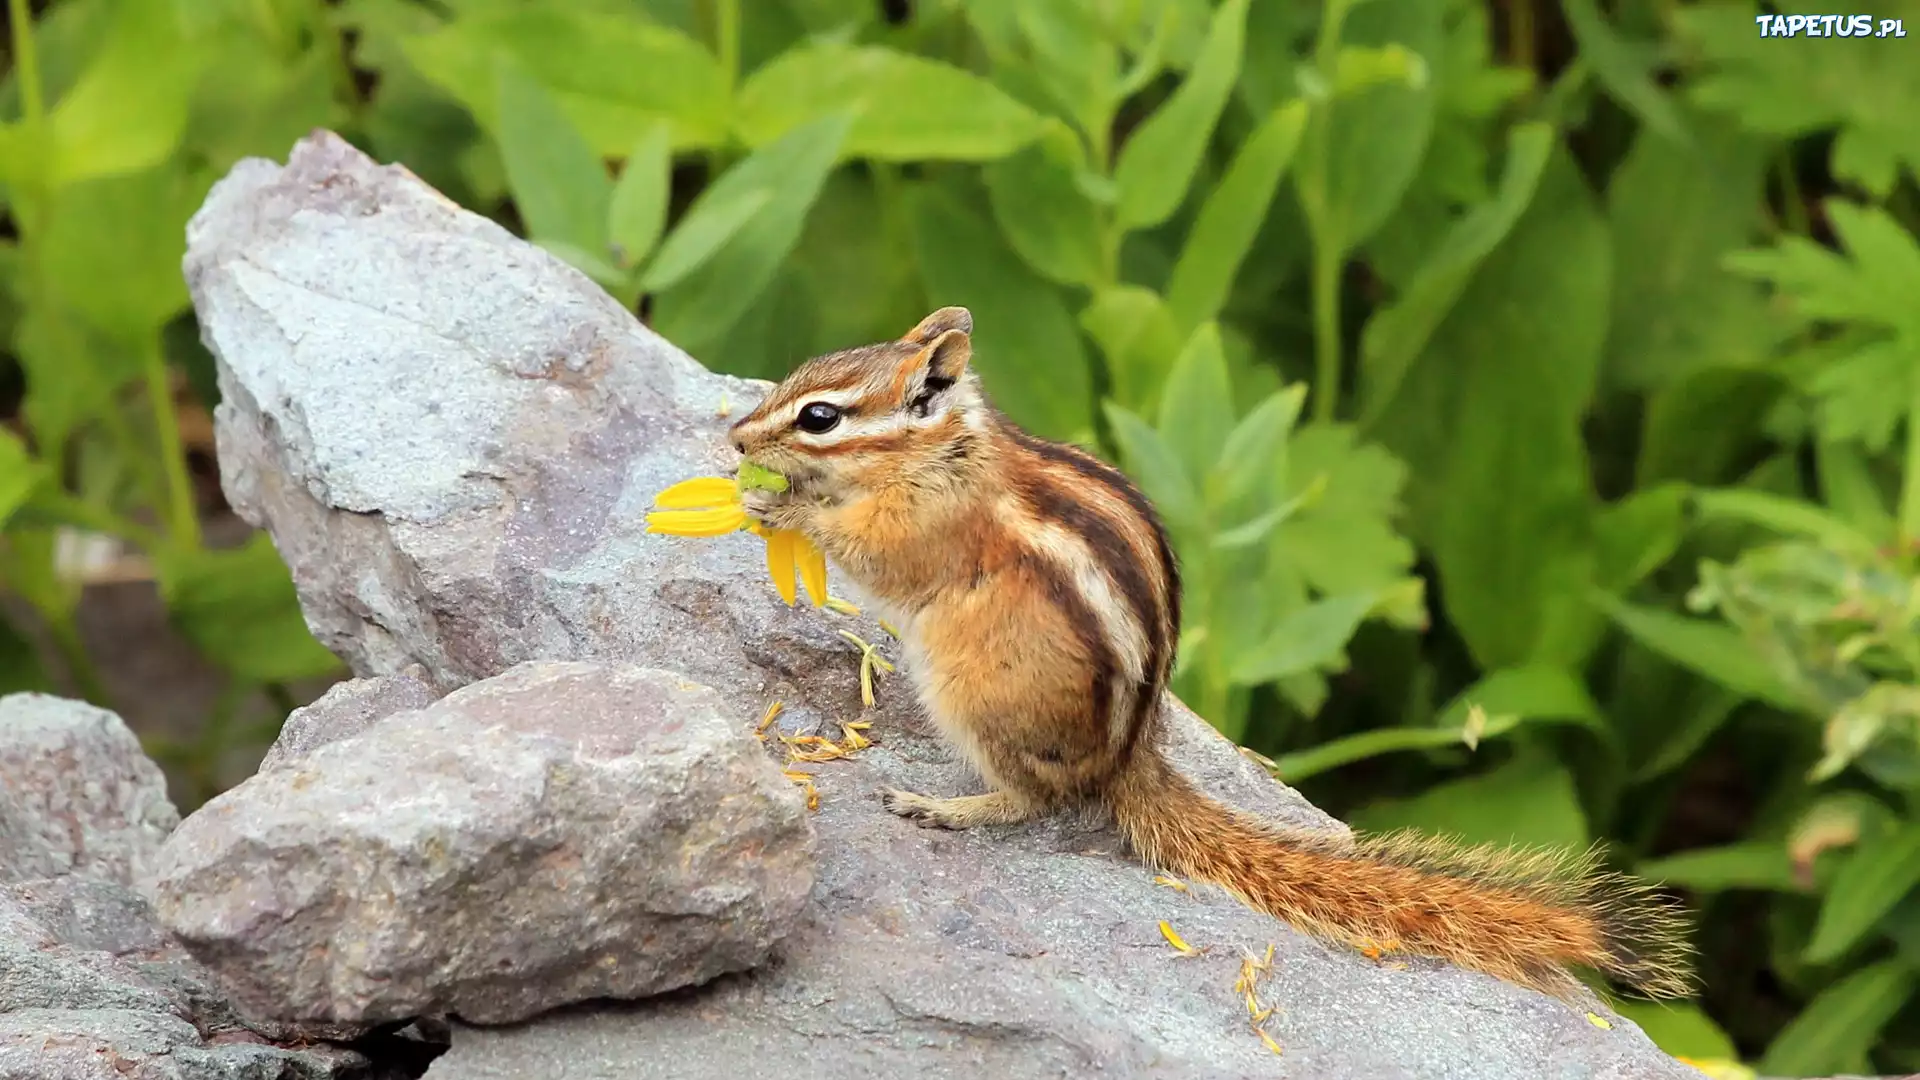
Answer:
[0, 0, 1920, 1076]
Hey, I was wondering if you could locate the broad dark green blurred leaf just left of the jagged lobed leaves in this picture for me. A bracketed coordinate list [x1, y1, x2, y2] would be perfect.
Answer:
[1607, 125, 1782, 390]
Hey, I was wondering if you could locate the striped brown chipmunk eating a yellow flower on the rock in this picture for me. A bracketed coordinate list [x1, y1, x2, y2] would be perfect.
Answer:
[730, 307, 1692, 1001]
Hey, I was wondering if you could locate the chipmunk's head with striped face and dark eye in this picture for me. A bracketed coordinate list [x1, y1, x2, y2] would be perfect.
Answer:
[732, 307, 989, 500]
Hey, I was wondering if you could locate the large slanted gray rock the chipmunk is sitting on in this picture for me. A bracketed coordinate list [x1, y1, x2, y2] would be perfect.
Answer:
[186, 135, 1697, 1080]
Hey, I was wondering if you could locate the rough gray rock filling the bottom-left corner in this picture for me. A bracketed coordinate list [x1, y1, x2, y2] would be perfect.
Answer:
[0, 874, 371, 1080]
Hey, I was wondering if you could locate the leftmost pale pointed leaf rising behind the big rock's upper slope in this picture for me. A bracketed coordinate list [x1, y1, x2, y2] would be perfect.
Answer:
[495, 58, 612, 258]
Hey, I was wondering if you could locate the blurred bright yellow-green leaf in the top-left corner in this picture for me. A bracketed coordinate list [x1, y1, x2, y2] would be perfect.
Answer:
[44, 0, 204, 188]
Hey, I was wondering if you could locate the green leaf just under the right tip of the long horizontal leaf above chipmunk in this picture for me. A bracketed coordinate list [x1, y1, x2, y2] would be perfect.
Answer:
[985, 123, 1106, 284]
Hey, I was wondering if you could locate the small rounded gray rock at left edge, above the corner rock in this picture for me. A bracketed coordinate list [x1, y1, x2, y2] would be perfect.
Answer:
[0, 694, 180, 884]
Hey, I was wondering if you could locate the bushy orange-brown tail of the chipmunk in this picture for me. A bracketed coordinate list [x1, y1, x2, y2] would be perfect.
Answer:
[1112, 755, 1692, 999]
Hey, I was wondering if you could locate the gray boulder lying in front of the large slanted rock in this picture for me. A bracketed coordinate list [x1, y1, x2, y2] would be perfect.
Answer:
[152, 663, 812, 1022]
